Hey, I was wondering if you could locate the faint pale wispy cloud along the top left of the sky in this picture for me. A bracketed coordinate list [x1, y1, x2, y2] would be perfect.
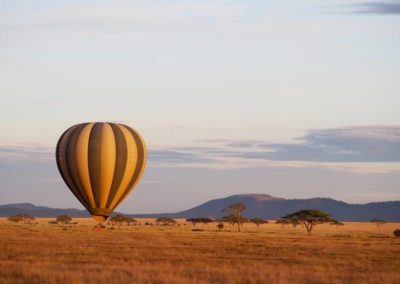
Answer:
[1, 0, 246, 32]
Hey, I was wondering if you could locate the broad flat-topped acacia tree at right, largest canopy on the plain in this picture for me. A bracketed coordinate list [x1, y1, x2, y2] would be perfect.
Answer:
[282, 210, 334, 236]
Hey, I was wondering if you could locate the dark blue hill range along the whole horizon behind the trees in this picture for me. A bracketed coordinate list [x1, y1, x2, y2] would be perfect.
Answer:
[0, 194, 400, 222]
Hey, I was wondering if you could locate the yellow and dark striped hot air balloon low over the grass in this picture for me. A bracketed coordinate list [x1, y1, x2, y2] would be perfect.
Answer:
[56, 122, 147, 222]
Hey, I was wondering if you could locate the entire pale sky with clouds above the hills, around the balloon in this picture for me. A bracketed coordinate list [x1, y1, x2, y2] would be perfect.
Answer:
[0, 0, 400, 213]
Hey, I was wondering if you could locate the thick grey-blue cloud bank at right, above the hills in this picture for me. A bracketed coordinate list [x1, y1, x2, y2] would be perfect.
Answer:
[230, 126, 400, 162]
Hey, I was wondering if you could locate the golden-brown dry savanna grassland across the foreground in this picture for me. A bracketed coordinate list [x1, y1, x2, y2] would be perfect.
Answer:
[0, 219, 400, 283]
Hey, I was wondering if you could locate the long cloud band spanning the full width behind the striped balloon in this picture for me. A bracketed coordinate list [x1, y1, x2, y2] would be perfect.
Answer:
[0, 126, 400, 174]
